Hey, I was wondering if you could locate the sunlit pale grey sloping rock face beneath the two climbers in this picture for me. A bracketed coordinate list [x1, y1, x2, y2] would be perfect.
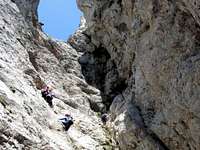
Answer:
[0, 0, 112, 150]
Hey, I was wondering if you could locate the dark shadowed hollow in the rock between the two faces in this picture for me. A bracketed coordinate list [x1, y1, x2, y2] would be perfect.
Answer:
[79, 46, 127, 112]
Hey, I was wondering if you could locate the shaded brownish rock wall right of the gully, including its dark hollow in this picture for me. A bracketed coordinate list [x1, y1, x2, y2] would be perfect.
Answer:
[75, 0, 200, 150]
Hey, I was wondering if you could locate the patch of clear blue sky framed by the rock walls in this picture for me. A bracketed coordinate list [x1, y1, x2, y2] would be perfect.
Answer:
[38, 0, 82, 41]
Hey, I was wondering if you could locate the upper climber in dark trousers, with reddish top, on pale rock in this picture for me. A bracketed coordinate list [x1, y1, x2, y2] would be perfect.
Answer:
[41, 86, 55, 107]
